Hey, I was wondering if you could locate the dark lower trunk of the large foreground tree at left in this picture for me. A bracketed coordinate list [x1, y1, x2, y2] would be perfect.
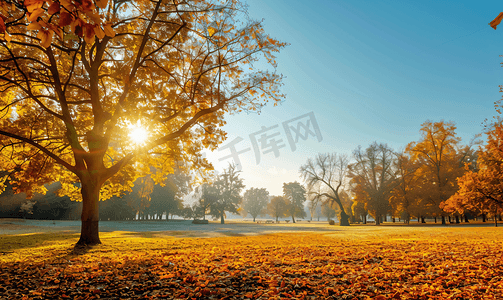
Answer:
[77, 179, 101, 246]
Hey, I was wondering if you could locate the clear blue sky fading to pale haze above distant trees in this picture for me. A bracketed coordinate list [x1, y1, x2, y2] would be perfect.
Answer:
[207, 0, 503, 195]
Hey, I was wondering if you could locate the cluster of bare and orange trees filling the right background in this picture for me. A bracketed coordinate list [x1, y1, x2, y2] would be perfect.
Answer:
[300, 121, 503, 225]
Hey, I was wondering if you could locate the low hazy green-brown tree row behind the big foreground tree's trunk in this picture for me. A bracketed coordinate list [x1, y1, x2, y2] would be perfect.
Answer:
[0, 172, 191, 221]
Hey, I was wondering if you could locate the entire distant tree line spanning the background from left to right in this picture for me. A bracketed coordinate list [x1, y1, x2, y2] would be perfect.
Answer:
[0, 119, 503, 225]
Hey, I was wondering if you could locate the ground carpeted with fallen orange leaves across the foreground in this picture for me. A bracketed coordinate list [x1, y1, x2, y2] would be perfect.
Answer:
[0, 226, 503, 299]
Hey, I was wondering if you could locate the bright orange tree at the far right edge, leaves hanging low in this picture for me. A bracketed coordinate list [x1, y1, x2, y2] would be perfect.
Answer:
[441, 121, 503, 225]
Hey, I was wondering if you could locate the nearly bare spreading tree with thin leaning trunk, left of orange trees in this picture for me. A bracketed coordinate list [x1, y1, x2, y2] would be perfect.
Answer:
[300, 153, 349, 226]
